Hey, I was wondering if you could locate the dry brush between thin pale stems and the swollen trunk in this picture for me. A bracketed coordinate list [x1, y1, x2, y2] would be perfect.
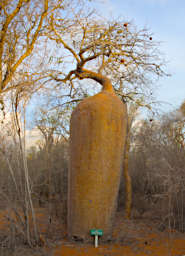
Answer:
[28, 141, 68, 223]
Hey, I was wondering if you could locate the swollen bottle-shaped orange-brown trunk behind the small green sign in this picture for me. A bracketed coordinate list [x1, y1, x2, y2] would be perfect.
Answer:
[68, 90, 127, 239]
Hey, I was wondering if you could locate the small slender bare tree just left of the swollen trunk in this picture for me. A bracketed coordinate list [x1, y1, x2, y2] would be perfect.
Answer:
[35, 106, 68, 224]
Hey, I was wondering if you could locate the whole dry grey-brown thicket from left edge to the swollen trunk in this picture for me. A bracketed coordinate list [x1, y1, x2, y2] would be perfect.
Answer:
[0, 138, 67, 249]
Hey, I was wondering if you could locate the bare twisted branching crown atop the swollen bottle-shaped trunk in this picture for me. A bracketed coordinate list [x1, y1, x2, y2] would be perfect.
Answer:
[44, 15, 168, 239]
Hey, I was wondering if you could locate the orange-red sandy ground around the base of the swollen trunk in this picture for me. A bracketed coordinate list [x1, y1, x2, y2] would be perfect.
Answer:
[0, 209, 185, 256]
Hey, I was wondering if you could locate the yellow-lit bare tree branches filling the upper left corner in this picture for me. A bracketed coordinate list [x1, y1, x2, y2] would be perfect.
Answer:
[0, 0, 83, 113]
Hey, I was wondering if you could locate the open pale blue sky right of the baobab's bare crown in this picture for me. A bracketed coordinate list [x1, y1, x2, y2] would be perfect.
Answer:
[98, 0, 185, 111]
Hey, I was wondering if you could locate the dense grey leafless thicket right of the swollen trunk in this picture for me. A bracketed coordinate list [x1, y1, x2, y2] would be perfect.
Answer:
[129, 101, 185, 232]
